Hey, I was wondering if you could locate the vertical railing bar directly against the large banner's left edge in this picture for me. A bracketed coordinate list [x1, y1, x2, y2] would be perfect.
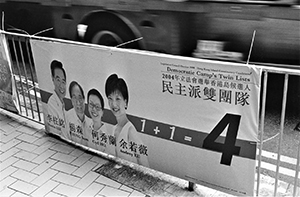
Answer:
[25, 39, 42, 121]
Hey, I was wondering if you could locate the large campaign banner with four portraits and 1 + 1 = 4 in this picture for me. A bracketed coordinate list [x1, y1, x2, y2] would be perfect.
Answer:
[31, 38, 261, 196]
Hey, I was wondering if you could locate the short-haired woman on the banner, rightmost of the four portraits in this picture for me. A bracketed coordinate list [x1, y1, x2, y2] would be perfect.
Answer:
[105, 74, 149, 167]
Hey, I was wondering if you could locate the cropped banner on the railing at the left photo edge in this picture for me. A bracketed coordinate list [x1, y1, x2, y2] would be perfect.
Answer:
[0, 31, 18, 112]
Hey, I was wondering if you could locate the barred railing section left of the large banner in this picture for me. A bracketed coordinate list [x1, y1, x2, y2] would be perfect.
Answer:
[6, 34, 43, 123]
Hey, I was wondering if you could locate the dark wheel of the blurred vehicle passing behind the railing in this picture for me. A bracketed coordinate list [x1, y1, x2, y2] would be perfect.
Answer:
[84, 13, 143, 49]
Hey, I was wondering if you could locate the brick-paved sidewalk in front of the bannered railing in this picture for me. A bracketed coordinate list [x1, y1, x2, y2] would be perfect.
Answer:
[0, 109, 234, 197]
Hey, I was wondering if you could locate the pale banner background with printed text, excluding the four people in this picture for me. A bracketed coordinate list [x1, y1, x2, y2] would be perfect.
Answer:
[31, 39, 261, 195]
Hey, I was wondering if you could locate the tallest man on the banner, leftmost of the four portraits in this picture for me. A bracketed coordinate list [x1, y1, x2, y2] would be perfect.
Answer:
[45, 60, 66, 137]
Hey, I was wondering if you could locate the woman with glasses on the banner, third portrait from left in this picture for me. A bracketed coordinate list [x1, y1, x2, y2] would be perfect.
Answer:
[87, 89, 112, 154]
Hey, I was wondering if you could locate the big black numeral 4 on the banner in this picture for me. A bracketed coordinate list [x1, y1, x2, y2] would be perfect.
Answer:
[203, 114, 241, 166]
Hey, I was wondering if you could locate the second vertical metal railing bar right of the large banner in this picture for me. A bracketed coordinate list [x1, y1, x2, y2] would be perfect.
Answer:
[274, 74, 289, 196]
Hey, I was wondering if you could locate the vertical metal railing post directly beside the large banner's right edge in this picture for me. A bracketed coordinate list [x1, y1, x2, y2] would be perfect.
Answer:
[256, 71, 268, 196]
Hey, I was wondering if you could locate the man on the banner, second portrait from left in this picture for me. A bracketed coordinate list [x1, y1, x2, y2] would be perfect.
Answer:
[66, 81, 92, 146]
